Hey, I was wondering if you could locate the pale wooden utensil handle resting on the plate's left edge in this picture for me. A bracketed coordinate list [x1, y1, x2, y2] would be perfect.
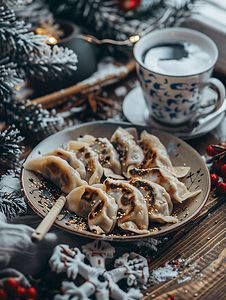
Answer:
[31, 195, 66, 243]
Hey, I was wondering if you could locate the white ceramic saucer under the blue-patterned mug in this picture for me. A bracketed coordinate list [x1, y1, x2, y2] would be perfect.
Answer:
[122, 86, 225, 140]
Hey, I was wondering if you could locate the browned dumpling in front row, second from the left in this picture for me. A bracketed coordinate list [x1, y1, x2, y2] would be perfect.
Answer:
[103, 178, 150, 234]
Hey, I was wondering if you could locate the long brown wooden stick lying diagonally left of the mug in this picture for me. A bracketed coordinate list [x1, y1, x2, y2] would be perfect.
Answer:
[26, 60, 136, 108]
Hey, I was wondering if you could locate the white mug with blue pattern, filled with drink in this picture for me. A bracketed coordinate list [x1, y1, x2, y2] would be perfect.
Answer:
[133, 27, 225, 125]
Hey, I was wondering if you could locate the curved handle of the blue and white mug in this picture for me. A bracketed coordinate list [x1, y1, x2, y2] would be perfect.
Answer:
[191, 77, 225, 123]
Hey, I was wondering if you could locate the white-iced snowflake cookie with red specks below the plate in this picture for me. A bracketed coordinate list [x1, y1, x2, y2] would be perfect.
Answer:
[49, 240, 149, 300]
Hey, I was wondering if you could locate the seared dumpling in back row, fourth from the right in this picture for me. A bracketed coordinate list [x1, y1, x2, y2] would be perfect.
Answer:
[66, 141, 103, 185]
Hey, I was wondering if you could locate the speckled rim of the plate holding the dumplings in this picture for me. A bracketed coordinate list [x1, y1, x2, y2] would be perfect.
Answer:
[20, 121, 211, 242]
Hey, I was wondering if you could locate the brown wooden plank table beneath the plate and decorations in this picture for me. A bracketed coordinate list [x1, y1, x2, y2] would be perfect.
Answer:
[3, 68, 226, 300]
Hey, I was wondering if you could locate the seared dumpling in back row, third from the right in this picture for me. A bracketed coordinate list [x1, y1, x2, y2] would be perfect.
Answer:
[78, 134, 121, 175]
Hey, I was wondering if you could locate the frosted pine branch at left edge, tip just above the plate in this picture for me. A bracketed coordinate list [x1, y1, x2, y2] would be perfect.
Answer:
[0, 60, 63, 139]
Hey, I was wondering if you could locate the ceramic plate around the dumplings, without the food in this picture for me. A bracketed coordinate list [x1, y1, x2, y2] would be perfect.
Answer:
[21, 121, 210, 241]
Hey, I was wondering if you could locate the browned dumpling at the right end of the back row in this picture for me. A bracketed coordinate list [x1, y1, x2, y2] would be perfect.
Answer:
[137, 130, 190, 178]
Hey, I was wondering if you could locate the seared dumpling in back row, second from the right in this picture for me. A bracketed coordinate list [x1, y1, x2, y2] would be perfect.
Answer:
[110, 127, 144, 177]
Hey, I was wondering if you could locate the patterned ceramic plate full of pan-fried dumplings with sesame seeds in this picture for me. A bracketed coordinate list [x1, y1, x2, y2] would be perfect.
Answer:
[21, 121, 210, 241]
